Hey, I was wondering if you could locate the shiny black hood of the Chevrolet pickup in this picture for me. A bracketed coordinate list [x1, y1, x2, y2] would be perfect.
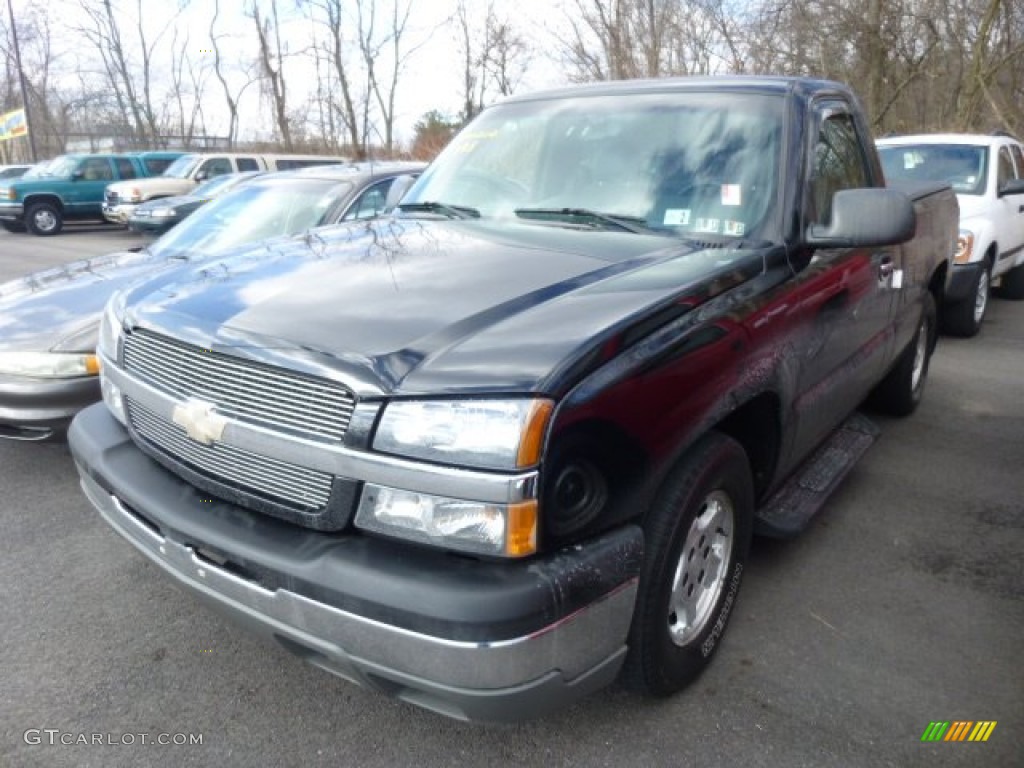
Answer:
[128, 219, 763, 396]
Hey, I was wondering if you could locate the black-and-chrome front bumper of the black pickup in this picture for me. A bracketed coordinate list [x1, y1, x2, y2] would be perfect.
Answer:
[69, 406, 643, 721]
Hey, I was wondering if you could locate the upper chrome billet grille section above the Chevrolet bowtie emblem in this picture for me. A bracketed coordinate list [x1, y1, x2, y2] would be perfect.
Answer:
[125, 330, 355, 440]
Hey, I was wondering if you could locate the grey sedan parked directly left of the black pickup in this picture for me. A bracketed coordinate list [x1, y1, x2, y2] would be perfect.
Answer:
[0, 163, 424, 440]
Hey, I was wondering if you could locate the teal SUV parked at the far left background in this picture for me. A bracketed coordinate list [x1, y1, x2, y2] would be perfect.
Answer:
[0, 152, 181, 236]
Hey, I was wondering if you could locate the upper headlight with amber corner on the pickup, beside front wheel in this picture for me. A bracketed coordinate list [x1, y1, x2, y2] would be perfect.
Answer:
[374, 398, 553, 471]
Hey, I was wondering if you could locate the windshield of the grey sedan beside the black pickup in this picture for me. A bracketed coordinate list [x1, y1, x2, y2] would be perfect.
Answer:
[150, 178, 352, 258]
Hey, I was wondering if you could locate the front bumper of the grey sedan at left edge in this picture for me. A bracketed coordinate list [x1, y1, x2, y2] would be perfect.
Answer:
[0, 374, 100, 440]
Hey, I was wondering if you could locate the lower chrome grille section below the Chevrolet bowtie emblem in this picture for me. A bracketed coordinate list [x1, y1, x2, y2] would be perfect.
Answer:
[128, 399, 333, 510]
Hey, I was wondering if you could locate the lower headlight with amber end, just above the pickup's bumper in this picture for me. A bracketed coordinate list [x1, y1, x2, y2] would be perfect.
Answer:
[355, 483, 537, 557]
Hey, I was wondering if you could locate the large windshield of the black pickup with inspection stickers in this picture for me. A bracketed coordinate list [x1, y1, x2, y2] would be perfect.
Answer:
[401, 91, 783, 237]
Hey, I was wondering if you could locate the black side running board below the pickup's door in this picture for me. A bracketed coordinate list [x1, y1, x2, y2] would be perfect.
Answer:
[754, 412, 880, 539]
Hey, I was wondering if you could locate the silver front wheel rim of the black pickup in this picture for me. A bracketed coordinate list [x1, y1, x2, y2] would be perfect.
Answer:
[668, 490, 736, 645]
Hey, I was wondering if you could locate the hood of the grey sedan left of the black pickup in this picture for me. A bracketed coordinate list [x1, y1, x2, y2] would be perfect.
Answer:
[0, 250, 180, 352]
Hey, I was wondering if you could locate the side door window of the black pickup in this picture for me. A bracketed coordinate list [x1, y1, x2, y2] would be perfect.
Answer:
[810, 111, 868, 224]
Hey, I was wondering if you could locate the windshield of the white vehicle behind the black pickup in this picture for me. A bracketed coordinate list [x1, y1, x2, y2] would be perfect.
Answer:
[879, 144, 988, 195]
